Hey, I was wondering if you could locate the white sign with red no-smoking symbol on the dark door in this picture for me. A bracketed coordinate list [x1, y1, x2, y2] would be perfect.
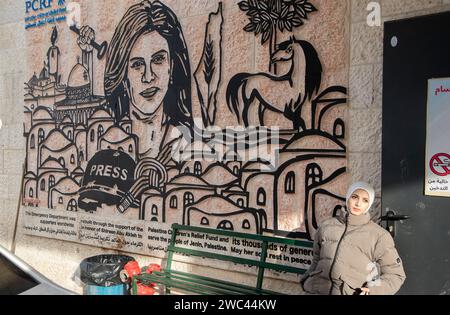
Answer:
[425, 78, 450, 197]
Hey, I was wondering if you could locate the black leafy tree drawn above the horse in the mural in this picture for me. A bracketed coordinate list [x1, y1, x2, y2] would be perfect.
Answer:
[238, 0, 317, 74]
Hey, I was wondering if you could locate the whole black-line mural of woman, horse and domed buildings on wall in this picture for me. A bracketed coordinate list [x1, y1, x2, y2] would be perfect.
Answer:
[23, 0, 347, 239]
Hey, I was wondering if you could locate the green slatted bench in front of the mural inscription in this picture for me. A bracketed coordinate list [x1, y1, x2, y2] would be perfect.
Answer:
[132, 224, 313, 295]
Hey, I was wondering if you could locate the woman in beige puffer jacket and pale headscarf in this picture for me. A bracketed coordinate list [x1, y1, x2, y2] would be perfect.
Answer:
[301, 182, 406, 295]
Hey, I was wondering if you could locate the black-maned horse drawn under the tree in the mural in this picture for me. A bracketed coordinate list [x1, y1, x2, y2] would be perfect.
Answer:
[226, 37, 322, 130]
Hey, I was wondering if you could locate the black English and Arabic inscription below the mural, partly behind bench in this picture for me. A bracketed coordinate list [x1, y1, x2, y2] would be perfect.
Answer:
[22, 207, 313, 279]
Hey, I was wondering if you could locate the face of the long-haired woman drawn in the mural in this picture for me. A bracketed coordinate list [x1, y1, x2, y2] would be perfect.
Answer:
[128, 32, 171, 115]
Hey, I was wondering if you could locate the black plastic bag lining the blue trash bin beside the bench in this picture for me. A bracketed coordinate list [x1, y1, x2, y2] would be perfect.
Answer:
[80, 255, 134, 287]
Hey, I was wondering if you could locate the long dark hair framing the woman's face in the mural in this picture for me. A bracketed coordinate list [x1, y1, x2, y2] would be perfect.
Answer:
[105, 0, 193, 127]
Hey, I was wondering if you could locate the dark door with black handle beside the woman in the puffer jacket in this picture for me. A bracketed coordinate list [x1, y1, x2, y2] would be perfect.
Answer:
[382, 12, 450, 295]
